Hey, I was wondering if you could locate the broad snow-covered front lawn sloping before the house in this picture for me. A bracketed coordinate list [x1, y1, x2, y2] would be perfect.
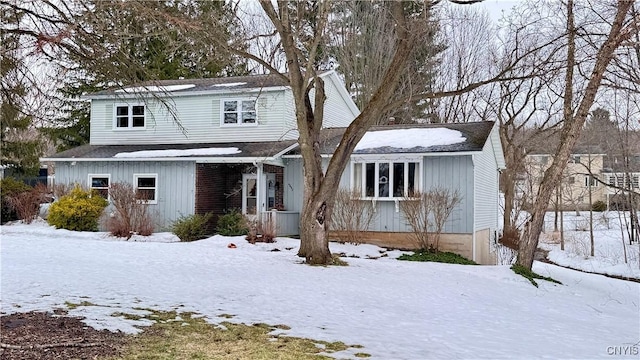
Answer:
[0, 223, 640, 359]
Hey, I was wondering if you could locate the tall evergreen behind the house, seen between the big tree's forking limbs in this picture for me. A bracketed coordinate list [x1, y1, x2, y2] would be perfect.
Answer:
[326, 1, 445, 123]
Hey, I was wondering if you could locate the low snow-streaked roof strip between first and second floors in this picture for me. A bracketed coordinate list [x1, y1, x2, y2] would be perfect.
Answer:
[42, 140, 297, 163]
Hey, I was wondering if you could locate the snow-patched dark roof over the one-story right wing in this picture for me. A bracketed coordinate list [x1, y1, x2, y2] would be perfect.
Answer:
[287, 121, 495, 155]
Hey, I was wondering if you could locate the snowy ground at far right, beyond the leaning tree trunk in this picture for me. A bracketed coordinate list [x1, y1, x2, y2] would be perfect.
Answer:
[540, 211, 640, 280]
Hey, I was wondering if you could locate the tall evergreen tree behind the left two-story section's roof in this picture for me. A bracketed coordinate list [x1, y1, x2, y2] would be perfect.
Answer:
[47, 0, 248, 151]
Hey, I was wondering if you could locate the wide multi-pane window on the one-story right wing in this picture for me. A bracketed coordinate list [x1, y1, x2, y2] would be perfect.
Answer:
[352, 161, 422, 199]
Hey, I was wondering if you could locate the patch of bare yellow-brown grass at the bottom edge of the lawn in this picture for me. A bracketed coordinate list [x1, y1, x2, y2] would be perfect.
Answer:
[107, 309, 361, 360]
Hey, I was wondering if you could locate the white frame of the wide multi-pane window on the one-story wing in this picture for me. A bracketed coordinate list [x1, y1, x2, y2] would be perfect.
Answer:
[350, 158, 423, 201]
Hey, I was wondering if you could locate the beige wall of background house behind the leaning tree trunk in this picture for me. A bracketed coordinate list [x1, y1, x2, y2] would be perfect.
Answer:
[520, 154, 608, 210]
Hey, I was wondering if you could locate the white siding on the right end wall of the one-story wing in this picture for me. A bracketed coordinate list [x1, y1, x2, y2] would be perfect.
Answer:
[474, 138, 499, 231]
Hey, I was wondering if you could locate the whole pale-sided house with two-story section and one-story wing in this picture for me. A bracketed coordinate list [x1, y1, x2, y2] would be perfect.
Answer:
[43, 71, 504, 264]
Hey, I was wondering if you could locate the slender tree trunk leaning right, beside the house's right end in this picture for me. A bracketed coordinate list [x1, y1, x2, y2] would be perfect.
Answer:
[518, 0, 637, 269]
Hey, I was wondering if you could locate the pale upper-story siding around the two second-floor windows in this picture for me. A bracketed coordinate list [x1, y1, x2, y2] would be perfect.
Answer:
[90, 90, 295, 145]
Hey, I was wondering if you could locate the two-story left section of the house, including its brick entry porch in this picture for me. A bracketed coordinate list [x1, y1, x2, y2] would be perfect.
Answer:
[43, 71, 359, 235]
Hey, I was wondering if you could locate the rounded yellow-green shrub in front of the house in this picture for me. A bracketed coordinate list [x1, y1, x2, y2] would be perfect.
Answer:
[47, 186, 109, 231]
